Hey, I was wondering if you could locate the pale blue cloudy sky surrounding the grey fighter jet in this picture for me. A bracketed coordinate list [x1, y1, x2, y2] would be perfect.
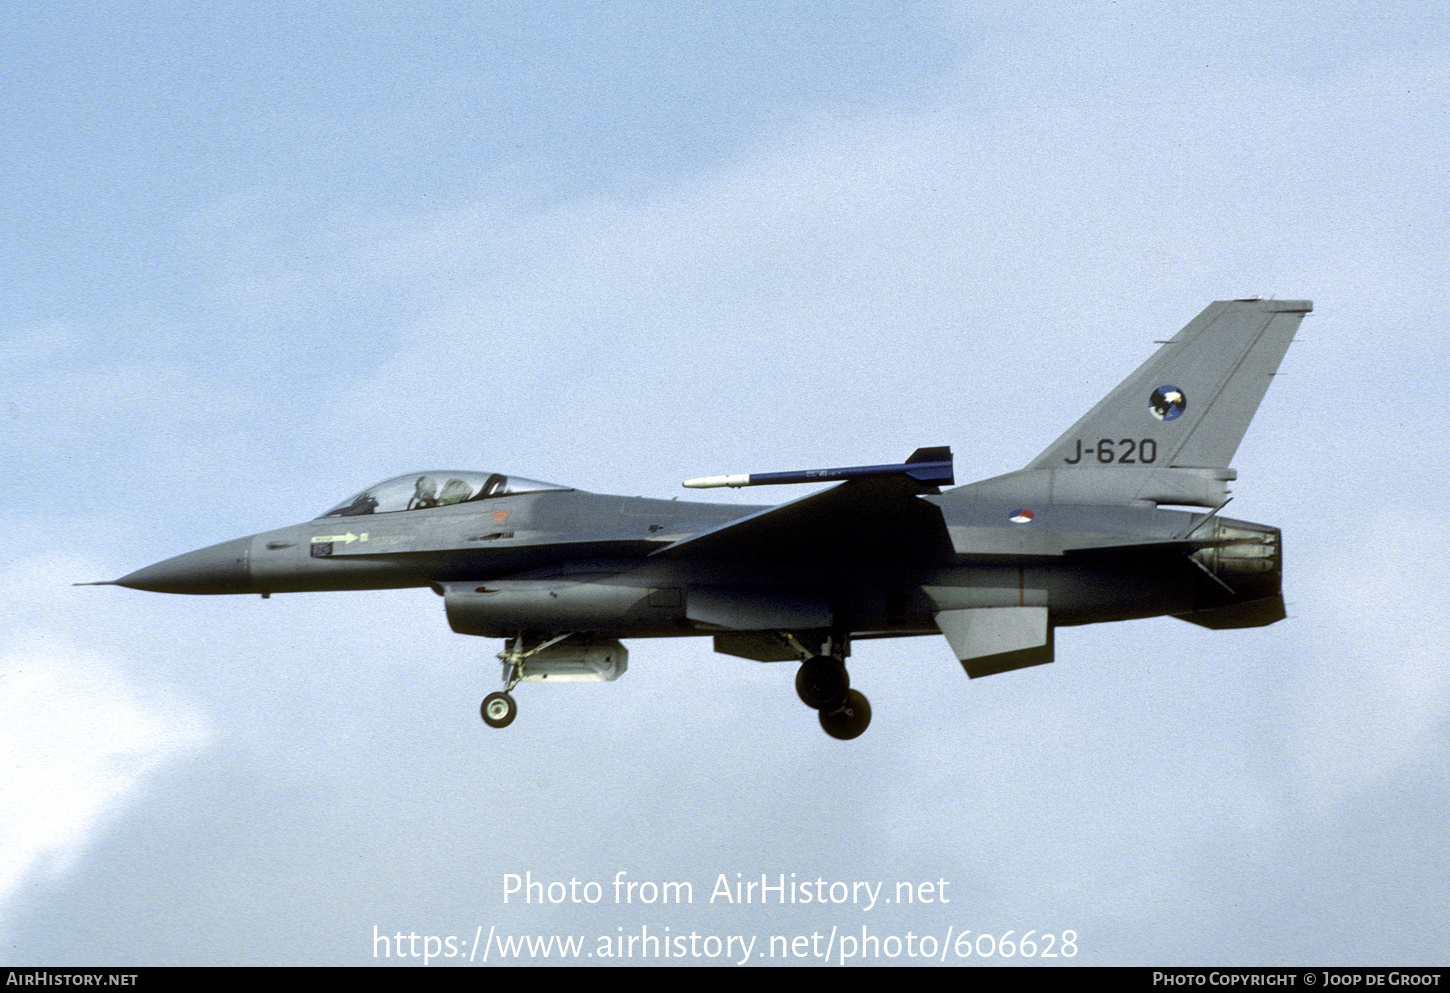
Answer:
[0, 0, 1450, 967]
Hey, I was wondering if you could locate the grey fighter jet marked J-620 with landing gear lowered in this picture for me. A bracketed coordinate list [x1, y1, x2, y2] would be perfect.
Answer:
[96, 299, 1312, 739]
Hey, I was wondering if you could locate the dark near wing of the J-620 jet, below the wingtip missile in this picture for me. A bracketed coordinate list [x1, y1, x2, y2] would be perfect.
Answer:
[653, 475, 953, 562]
